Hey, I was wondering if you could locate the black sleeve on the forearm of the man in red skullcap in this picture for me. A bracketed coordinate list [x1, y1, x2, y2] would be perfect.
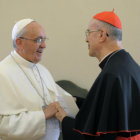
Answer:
[62, 116, 84, 140]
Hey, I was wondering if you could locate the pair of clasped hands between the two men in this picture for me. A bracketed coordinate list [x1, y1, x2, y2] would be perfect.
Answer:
[44, 102, 67, 122]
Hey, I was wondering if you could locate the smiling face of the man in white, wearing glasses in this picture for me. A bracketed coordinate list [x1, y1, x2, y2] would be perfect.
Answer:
[17, 22, 46, 63]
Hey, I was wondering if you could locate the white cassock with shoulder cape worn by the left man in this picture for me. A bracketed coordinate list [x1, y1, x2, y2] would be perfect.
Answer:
[0, 51, 69, 140]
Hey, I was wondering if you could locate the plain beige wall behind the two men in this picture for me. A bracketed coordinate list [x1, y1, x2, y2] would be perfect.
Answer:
[0, 0, 140, 89]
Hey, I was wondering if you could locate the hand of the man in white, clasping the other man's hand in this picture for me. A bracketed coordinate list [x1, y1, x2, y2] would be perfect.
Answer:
[44, 102, 59, 120]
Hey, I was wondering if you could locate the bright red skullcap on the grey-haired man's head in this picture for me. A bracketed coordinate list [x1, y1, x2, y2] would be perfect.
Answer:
[93, 11, 122, 30]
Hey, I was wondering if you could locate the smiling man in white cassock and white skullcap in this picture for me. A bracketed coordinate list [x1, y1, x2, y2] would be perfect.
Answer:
[0, 19, 72, 140]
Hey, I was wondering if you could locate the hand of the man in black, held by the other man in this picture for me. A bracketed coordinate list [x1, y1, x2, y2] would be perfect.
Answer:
[55, 104, 67, 122]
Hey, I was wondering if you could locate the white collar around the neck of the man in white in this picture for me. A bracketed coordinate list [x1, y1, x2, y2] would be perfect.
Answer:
[11, 50, 35, 68]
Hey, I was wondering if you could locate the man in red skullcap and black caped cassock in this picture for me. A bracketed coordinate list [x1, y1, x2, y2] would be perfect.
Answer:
[56, 11, 140, 140]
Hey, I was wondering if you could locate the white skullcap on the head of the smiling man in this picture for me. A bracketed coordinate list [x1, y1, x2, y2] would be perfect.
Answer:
[12, 19, 35, 40]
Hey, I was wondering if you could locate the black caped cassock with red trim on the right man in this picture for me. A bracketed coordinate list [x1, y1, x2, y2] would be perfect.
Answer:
[62, 49, 140, 140]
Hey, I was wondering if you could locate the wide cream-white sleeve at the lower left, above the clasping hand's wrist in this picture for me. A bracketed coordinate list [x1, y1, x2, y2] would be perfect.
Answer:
[0, 111, 46, 140]
